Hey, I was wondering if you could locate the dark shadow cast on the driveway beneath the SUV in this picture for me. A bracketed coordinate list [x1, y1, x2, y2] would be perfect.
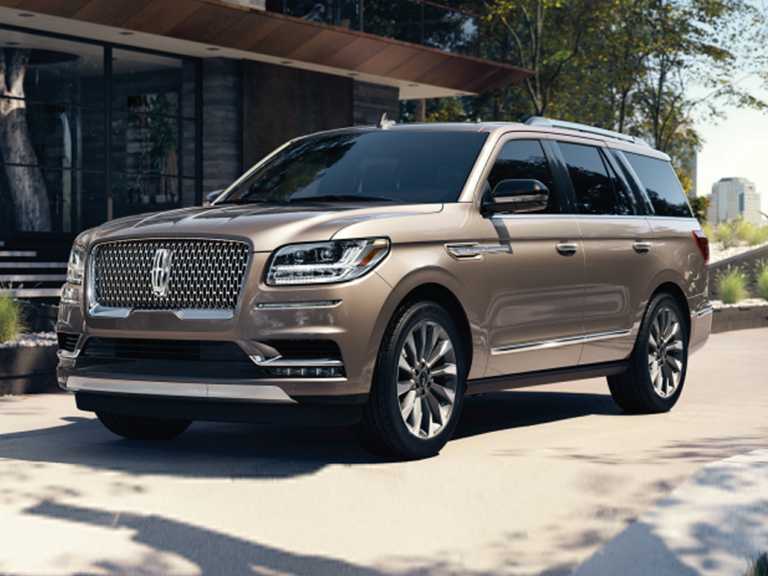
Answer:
[0, 391, 619, 478]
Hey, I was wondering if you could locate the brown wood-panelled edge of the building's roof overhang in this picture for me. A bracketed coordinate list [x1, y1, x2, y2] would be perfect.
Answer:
[0, 0, 530, 94]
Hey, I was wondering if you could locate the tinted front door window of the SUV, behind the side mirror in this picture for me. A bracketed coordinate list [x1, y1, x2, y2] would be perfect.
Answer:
[488, 140, 560, 214]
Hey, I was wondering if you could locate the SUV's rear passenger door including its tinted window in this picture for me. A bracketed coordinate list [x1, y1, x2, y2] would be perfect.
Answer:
[557, 139, 653, 364]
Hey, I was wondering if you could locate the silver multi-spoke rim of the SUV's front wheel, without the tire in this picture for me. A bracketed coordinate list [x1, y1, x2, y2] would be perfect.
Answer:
[397, 320, 458, 439]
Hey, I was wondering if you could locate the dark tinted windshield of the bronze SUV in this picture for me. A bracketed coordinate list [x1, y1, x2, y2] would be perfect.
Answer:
[217, 130, 487, 204]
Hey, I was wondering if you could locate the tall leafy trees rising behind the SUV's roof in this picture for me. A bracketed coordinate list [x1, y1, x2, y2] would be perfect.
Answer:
[414, 0, 768, 169]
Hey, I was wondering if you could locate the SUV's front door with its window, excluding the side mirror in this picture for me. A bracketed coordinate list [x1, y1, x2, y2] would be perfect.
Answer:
[481, 136, 584, 377]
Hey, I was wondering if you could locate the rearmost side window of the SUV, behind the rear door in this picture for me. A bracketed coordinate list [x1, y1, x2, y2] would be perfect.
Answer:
[624, 152, 693, 218]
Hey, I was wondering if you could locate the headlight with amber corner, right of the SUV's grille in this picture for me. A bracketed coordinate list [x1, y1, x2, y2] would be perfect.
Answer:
[267, 238, 389, 286]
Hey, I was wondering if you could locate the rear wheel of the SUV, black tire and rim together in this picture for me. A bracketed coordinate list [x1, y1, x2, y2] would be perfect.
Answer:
[608, 293, 688, 414]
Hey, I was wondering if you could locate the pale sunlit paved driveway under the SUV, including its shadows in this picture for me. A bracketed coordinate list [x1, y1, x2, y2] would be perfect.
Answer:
[0, 330, 768, 575]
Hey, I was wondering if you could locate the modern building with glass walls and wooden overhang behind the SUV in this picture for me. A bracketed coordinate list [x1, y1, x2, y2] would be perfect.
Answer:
[0, 0, 528, 290]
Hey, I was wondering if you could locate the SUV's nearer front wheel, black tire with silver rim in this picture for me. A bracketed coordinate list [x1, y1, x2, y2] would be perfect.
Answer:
[361, 302, 467, 460]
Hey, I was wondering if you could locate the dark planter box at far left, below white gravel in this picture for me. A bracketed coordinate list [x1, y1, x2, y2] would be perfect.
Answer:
[0, 344, 58, 395]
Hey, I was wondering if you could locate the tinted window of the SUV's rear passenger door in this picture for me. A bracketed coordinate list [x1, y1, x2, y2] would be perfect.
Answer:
[558, 142, 634, 215]
